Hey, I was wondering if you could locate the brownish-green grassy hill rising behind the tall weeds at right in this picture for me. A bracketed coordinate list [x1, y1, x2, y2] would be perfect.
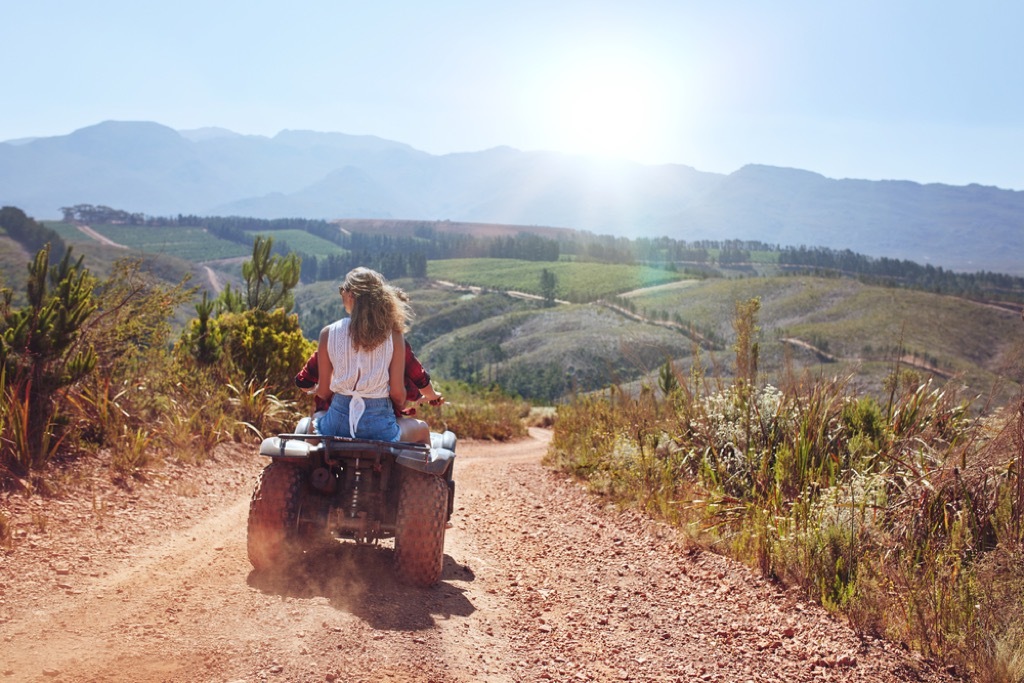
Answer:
[618, 278, 1022, 401]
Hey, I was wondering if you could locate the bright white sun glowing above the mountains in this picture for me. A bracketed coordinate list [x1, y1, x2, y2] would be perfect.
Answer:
[545, 58, 665, 161]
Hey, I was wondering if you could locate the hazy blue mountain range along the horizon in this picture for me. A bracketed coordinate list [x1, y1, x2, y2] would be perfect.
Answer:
[0, 121, 1024, 275]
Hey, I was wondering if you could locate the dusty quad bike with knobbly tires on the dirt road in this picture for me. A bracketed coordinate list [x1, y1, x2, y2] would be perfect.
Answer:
[248, 418, 456, 586]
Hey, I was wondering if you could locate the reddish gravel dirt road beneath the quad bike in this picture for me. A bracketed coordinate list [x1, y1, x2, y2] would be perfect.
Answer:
[0, 430, 945, 683]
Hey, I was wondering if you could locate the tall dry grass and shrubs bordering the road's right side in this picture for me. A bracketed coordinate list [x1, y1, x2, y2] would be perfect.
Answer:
[547, 304, 1024, 681]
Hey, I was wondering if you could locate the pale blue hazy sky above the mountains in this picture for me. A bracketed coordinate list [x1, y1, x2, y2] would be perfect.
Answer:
[0, 0, 1024, 189]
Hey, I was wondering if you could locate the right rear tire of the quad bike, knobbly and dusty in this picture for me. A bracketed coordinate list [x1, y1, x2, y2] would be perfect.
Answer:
[394, 470, 449, 587]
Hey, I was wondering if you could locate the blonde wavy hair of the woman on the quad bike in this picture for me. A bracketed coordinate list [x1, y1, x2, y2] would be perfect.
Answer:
[338, 266, 413, 351]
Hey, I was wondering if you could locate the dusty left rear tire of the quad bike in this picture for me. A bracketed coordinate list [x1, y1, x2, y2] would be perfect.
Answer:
[248, 463, 303, 571]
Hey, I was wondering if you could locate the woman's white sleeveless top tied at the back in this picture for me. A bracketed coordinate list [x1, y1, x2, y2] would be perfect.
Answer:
[327, 317, 394, 434]
